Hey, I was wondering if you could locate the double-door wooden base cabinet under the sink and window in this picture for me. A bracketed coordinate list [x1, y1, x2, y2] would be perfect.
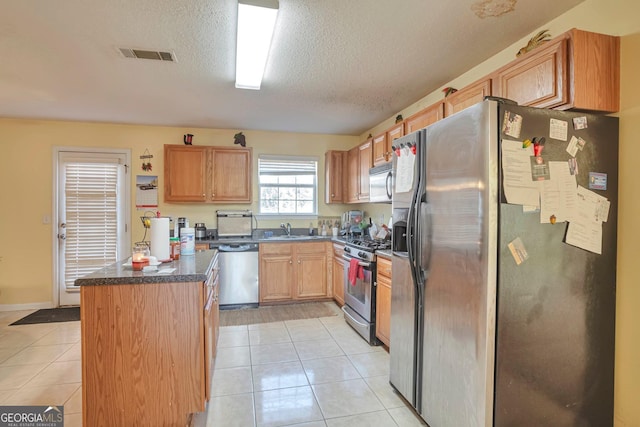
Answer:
[259, 242, 331, 303]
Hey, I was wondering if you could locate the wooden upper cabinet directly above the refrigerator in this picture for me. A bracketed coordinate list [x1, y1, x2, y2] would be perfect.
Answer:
[495, 29, 620, 112]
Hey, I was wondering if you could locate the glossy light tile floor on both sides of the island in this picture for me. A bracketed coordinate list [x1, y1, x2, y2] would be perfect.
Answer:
[0, 311, 430, 427]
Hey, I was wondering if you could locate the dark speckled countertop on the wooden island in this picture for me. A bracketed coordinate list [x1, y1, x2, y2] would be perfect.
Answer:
[75, 250, 218, 286]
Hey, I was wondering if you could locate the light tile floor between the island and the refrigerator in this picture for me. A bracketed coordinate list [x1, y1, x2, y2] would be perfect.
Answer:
[206, 316, 423, 427]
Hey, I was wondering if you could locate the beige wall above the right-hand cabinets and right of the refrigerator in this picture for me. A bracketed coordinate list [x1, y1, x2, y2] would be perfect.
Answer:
[360, 0, 640, 427]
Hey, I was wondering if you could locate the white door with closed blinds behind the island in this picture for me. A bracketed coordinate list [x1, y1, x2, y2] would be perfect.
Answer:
[57, 151, 130, 306]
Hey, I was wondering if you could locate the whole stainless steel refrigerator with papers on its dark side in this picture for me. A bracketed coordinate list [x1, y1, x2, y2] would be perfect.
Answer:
[389, 100, 618, 427]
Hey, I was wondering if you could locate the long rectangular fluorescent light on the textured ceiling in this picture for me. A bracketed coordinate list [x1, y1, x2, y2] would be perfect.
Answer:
[236, 0, 278, 90]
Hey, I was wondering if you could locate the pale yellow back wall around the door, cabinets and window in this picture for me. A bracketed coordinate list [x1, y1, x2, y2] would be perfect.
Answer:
[0, 119, 357, 309]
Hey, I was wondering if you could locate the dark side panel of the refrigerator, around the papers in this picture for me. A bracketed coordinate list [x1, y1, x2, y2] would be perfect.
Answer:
[495, 107, 618, 427]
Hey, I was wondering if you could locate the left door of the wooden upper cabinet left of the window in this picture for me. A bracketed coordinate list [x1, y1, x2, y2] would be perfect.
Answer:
[164, 145, 208, 202]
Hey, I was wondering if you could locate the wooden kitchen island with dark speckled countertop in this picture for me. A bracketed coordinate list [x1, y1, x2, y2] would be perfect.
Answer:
[76, 250, 219, 426]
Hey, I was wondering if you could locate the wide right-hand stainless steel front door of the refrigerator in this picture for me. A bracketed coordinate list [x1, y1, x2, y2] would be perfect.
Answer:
[420, 102, 498, 427]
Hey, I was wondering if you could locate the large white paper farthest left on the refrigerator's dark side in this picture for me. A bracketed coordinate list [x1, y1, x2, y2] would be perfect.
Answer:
[502, 139, 540, 207]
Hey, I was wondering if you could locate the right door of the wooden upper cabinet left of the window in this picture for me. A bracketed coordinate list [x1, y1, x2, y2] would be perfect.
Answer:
[210, 147, 251, 202]
